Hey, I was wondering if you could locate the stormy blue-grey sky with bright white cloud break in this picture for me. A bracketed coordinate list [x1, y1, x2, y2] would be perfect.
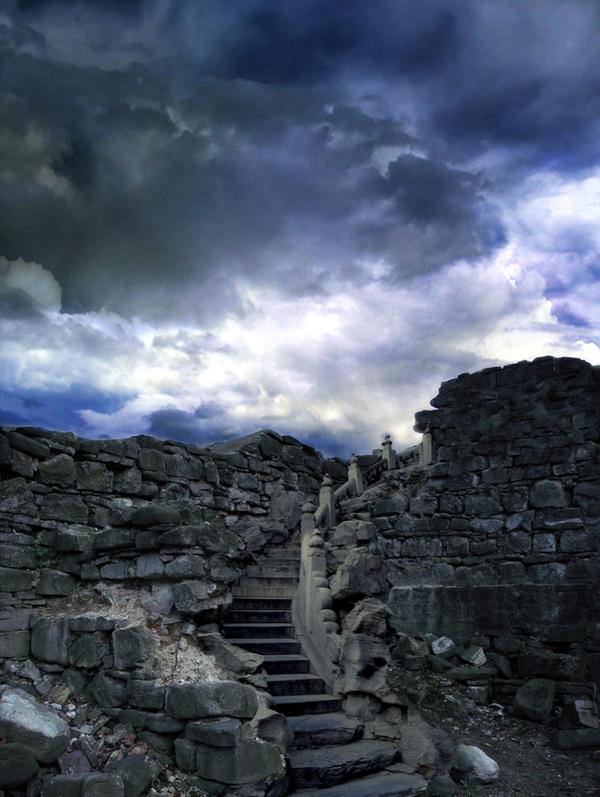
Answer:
[0, 0, 600, 456]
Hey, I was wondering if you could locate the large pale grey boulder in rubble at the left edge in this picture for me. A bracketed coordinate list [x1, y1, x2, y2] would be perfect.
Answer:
[0, 687, 70, 763]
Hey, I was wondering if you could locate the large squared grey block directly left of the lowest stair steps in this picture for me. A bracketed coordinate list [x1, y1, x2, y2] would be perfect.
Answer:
[197, 739, 285, 786]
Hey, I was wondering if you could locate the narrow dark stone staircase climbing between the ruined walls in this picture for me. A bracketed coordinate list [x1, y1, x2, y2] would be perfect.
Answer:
[223, 540, 426, 797]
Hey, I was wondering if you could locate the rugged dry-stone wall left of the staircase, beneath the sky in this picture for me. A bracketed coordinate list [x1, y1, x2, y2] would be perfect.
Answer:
[0, 428, 345, 636]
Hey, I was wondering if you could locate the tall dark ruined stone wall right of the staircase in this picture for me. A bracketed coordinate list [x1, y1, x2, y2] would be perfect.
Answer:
[371, 357, 600, 682]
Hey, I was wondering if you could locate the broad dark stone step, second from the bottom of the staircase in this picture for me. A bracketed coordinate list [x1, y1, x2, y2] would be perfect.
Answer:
[289, 740, 400, 797]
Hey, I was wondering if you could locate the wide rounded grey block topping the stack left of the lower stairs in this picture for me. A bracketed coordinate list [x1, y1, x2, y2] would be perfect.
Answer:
[166, 681, 258, 719]
